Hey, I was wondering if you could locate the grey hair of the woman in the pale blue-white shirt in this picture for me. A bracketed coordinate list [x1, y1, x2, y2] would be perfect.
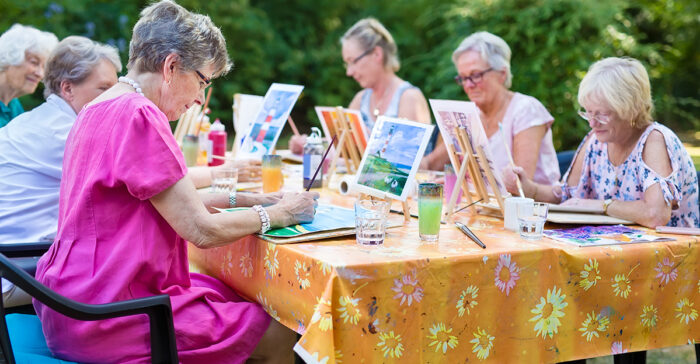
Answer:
[44, 35, 122, 97]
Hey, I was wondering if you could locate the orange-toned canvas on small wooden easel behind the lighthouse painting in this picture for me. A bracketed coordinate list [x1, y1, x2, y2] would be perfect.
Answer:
[315, 106, 367, 179]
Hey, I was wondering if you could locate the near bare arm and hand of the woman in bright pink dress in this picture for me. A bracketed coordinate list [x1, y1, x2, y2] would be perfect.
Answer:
[150, 178, 318, 248]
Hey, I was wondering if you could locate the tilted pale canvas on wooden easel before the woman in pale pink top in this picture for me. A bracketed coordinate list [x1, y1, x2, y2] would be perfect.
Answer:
[430, 99, 508, 196]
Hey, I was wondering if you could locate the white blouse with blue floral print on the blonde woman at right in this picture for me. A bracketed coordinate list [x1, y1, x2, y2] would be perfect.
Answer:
[562, 122, 700, 227]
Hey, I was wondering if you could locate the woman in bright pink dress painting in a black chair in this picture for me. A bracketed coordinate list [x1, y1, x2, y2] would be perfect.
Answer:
[35, 1, 318, 363]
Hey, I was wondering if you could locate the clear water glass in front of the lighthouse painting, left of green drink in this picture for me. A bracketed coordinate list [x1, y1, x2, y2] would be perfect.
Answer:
[355, 200, 390, 245]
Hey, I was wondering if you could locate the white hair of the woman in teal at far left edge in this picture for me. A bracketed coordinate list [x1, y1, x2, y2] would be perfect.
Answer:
[0, 24, 58, 72]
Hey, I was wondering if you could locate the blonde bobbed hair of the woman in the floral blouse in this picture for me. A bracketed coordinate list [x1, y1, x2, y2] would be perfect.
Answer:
[578, 57, 654, 128]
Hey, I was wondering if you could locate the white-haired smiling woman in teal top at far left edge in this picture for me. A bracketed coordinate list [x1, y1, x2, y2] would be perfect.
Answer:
[0, 24, 58, 128]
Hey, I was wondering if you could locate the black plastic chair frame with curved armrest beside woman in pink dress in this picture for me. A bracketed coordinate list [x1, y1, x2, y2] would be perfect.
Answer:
[0, 254, 178, 364]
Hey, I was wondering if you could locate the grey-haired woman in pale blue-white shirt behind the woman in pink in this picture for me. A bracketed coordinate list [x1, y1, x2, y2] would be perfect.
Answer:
[0, 36, 122, 307]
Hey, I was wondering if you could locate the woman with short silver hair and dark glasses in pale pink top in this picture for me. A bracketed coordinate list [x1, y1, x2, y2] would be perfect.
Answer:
[422, 32, 559, 188]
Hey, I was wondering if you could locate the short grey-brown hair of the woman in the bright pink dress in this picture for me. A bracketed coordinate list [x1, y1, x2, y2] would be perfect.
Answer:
[127, 0, 233, 77]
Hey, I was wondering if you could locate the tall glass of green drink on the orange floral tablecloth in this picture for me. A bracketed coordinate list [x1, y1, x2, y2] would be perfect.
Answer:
[418, 183, 442, 242]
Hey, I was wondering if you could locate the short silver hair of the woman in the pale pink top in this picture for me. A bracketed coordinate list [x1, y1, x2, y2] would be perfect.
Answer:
[452, 32, 513, 88]
